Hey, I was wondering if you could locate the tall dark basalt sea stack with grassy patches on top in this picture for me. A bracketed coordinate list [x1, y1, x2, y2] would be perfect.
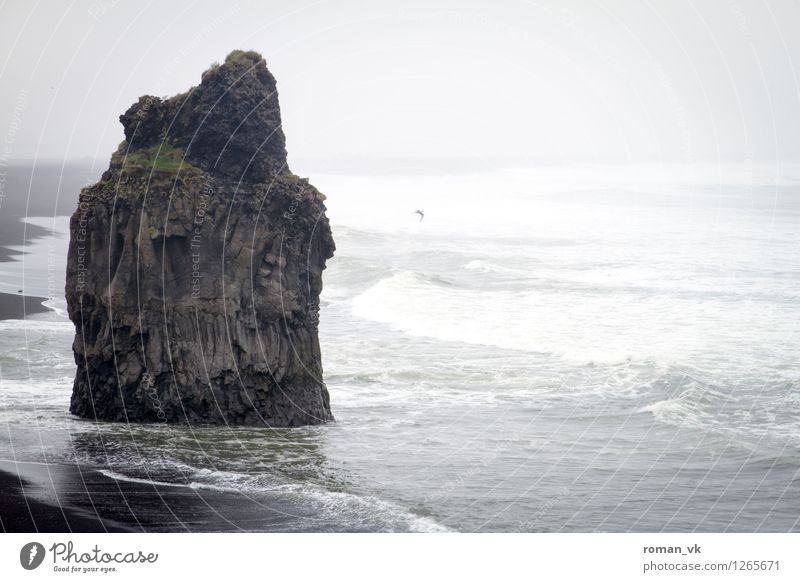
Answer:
[66, 51, 334, 426]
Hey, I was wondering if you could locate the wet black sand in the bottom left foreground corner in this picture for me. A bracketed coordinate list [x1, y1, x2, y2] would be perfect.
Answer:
[0, 461, 334, 533]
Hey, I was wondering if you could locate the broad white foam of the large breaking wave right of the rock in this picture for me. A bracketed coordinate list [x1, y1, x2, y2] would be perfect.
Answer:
[352, 271, 798, 366]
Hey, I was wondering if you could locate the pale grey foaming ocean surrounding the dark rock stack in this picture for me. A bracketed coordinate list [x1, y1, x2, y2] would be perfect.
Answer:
[0, 164, 800, 532]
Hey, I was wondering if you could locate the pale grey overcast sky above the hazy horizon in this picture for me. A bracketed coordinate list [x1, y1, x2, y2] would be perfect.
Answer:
[0, 0, 800, 161]
